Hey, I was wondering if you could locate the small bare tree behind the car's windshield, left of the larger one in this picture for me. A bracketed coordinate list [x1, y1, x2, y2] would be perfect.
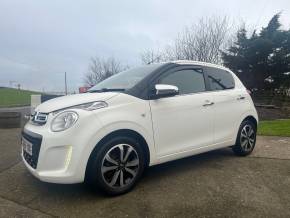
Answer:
[84, 57, 128, 87]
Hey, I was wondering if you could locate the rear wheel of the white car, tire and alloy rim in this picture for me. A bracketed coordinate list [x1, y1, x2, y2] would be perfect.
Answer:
[232, 120, 257, 156]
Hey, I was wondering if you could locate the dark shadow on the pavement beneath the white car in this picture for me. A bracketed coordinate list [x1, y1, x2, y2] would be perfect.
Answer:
[26, 148, 236, 199]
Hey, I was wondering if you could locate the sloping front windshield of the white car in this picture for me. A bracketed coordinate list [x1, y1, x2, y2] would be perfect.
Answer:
[88, 64, 162, 92]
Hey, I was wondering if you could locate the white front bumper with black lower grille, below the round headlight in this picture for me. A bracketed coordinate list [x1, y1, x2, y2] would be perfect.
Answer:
[21, 110, 101, 184]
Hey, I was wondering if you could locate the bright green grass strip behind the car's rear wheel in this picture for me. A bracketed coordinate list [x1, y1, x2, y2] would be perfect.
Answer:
[258, 119, 290, 137]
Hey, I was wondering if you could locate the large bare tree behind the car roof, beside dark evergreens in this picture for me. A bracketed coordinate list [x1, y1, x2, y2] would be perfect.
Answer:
[141, 17, 231, 63]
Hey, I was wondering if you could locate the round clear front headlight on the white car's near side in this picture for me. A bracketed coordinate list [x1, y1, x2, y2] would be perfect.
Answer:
[51, 111, 79, 132]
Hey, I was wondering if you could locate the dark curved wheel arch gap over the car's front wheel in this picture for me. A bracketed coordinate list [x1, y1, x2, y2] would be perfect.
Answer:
[85, 129, 150, 181]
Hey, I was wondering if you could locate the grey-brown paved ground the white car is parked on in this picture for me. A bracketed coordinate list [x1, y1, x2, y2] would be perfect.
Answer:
[0, 129, 290, 217]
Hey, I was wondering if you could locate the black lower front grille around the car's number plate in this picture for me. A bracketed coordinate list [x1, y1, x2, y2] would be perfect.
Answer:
[22, 132, 42, 169]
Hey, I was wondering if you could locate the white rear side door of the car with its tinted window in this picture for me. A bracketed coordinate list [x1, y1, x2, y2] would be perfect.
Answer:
[205, 67, 244, 145]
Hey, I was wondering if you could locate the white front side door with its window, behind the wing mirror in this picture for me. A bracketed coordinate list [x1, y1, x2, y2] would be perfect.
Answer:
[150, 66, 213, 157]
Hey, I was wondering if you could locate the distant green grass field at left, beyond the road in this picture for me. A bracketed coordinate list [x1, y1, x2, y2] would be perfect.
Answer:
[0, 88, 39, 107]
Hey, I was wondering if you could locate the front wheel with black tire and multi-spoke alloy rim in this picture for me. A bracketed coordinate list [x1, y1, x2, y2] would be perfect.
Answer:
[87, 136, 145, 195]
